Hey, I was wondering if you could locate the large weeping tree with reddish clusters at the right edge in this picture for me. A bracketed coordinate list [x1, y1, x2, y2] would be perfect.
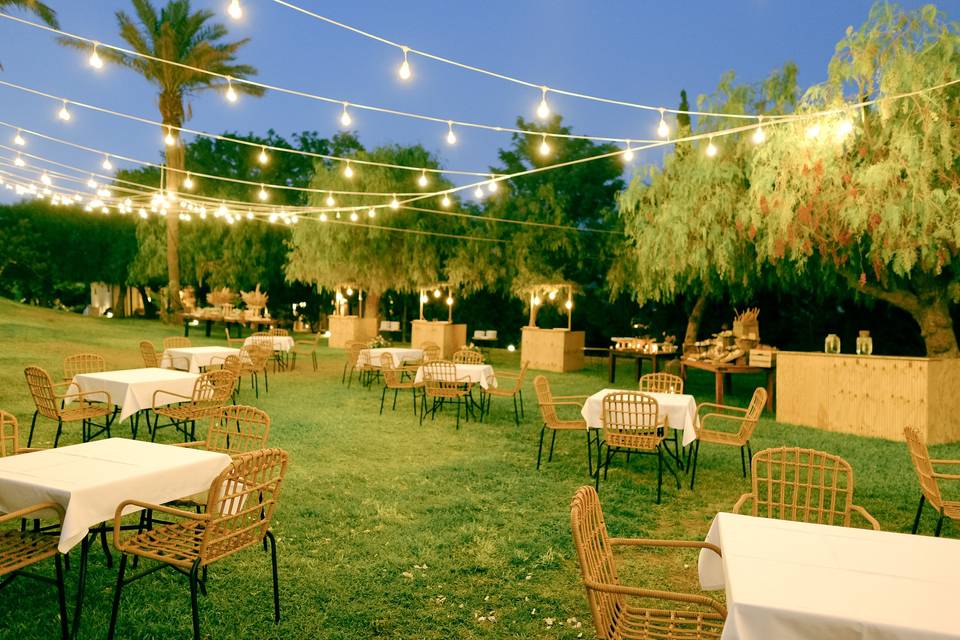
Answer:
[742, 4, 960, 356]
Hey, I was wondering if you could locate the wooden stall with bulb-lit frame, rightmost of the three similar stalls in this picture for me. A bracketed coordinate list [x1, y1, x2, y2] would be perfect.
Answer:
[520, 284, 585, 372]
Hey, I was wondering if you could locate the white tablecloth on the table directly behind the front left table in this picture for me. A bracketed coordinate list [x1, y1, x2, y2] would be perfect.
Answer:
[71, 367, 199, 420]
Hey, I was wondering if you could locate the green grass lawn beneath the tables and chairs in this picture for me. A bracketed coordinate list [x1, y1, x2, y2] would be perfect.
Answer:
[0, 301, 960, 640]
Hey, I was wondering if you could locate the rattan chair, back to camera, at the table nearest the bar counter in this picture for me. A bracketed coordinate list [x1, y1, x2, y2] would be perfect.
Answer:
[595, 391, 680, 504]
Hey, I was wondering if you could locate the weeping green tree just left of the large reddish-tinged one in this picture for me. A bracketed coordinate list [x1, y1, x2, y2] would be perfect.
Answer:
[609, 64, 797, 342]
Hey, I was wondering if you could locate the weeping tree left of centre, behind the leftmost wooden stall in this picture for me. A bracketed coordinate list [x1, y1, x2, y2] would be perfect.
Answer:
[286, 145, 464, 313]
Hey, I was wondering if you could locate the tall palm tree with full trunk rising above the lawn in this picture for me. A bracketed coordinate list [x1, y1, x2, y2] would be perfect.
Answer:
[62, 0, 263, 310]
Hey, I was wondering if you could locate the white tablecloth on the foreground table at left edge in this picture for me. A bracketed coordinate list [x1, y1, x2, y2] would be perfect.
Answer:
[0, 438, 230, 553]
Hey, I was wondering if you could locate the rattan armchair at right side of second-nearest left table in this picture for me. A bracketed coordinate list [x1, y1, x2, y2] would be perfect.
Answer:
[150, 369, 237, 442]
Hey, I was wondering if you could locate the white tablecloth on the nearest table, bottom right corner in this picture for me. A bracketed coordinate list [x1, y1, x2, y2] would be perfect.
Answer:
[699, 513, 960, 640]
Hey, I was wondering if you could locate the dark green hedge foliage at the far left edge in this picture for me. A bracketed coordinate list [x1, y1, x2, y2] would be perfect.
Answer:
[0, 201, 137, 306]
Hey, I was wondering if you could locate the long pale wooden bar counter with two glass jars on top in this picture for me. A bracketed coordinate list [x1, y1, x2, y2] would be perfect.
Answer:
[777, 351, 960, 444]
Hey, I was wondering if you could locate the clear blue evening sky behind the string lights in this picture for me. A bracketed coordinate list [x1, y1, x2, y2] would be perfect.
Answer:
[0, 0, 936, 201]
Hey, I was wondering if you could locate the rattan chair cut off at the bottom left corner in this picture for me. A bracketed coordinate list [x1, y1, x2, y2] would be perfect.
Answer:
[0, 502, 70, 640]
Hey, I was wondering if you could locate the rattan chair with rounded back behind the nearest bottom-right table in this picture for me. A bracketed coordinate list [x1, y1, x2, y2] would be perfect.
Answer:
[733, 447, 880, 531]
